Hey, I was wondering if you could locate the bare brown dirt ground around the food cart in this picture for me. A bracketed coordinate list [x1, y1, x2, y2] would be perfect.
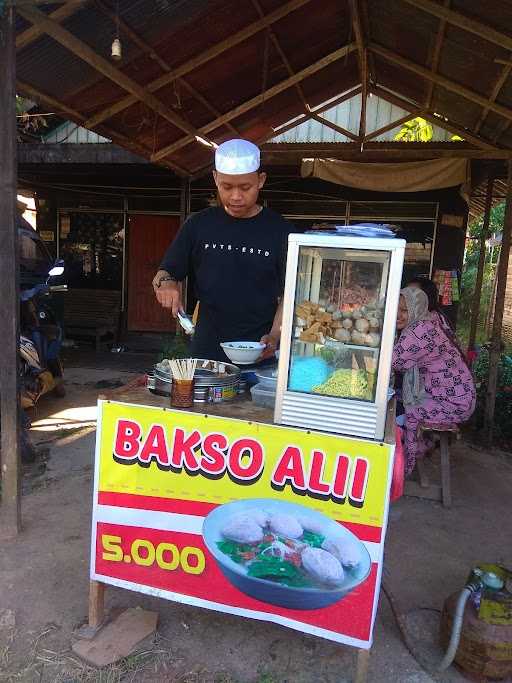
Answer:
[0, 354, 512, 683]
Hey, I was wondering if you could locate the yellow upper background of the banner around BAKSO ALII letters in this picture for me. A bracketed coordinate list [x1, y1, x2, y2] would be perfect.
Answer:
[98, 401, 393, 527]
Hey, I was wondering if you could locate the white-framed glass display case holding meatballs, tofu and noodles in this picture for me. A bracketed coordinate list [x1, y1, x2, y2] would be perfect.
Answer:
[275, 234, 405, 440]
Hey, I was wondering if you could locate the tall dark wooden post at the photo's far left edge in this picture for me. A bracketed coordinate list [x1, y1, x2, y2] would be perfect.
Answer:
[0, 3, 21, 538]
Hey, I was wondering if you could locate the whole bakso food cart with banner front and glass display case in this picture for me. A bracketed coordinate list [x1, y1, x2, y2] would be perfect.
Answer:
[89, 235, 404, 681]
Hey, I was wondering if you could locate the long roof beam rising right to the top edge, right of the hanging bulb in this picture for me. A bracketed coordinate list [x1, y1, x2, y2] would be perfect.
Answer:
[87, 0, 311, 128]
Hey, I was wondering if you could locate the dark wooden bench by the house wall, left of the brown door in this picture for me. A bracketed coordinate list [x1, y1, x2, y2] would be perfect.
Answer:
[64, 289, 121, 351]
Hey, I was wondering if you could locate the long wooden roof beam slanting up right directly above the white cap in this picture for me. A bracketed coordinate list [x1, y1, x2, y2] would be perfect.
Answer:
[151, 43, 355, 161]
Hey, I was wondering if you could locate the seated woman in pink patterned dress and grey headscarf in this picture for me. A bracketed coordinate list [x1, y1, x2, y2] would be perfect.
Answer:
[393, 287, 476, 474]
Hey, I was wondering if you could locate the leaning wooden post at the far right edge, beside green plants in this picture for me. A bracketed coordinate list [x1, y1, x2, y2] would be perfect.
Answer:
[484, 159, 512, 444]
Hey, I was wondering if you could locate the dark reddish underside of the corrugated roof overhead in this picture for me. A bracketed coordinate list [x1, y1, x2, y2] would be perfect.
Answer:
[16, 0, 512, 175]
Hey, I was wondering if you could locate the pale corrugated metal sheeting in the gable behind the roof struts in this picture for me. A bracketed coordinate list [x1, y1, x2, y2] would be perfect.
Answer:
[270, 95, 452, 143]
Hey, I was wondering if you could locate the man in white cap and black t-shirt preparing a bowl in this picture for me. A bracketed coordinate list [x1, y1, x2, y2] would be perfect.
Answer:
[153, 140, 292, 360]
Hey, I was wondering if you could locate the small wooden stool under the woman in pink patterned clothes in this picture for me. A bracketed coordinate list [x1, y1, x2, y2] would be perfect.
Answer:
[405, 422, 460, 508]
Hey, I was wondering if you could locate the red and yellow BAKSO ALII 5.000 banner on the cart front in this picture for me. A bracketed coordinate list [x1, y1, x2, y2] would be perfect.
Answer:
[91, 401, 394, 648]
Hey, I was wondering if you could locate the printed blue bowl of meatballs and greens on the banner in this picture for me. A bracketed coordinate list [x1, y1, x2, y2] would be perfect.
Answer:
[203, 498, 371, 610]
